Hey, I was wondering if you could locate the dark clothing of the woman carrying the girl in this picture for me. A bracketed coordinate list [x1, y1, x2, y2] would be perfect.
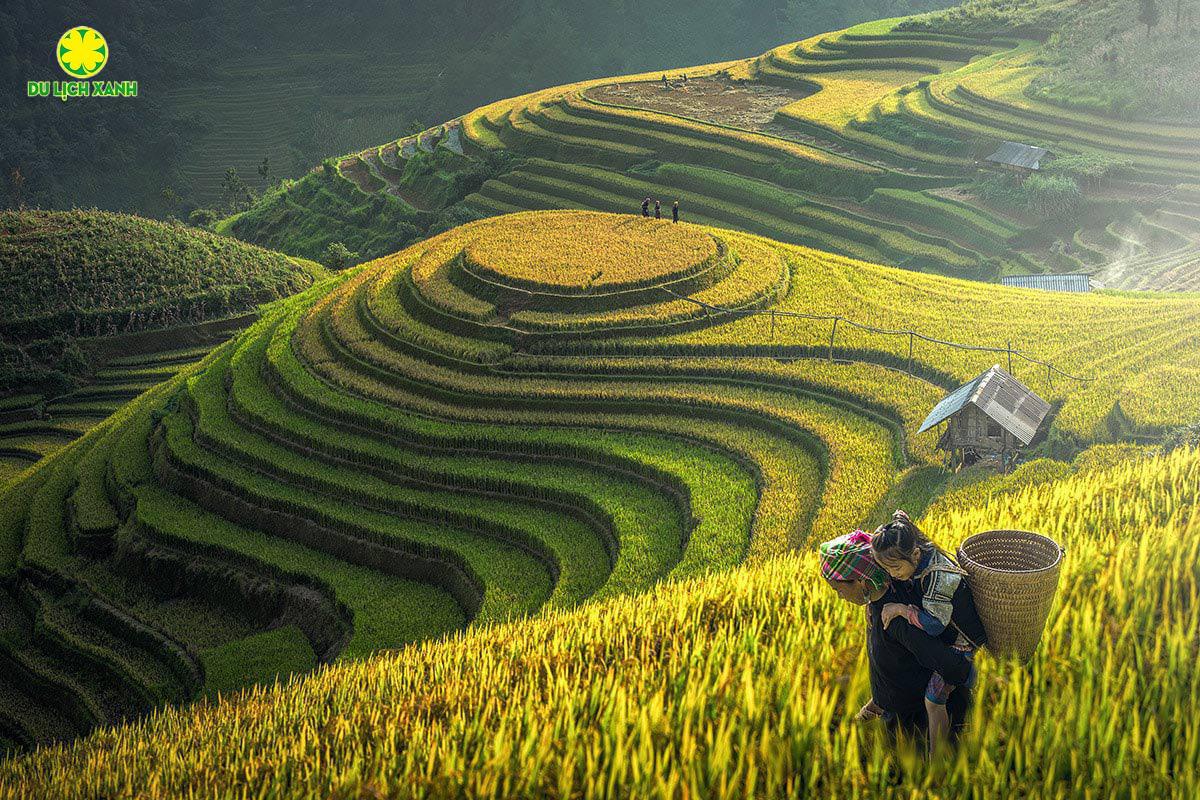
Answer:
[866, 581, 971, 729]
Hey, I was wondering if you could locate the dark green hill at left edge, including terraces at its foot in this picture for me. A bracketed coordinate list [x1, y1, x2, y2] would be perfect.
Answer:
[0, 211, 326, 485]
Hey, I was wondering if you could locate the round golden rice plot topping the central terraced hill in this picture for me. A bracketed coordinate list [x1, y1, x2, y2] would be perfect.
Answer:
[464, 206, 718, 294]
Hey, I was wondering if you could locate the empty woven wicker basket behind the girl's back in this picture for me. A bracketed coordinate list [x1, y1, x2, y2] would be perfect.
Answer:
[959, 530, 1063, 661]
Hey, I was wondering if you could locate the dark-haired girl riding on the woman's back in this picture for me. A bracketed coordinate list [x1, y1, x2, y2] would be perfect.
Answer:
[871, 511, 988, 750]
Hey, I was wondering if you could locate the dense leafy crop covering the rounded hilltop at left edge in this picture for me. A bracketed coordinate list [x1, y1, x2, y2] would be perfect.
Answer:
[0, 211, 324, 393]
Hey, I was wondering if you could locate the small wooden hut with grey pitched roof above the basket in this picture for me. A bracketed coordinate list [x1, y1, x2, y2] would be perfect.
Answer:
[918, 363, 1050, 463]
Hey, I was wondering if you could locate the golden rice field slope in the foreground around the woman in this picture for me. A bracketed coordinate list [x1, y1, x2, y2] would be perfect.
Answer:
[0, 441, 1200, 798]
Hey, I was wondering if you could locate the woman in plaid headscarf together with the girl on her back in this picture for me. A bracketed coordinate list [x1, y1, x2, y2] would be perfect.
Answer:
[820, 511, 988, 751]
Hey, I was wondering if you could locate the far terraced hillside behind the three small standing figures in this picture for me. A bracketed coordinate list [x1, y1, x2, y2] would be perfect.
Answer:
[220, 2, 1200, 290]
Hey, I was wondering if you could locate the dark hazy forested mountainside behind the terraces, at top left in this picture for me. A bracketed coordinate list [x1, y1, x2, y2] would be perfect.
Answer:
[0, 0, 947, 217]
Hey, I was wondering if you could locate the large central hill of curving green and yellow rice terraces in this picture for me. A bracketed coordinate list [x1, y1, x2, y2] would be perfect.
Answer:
[0, 211, 1200, 767]
